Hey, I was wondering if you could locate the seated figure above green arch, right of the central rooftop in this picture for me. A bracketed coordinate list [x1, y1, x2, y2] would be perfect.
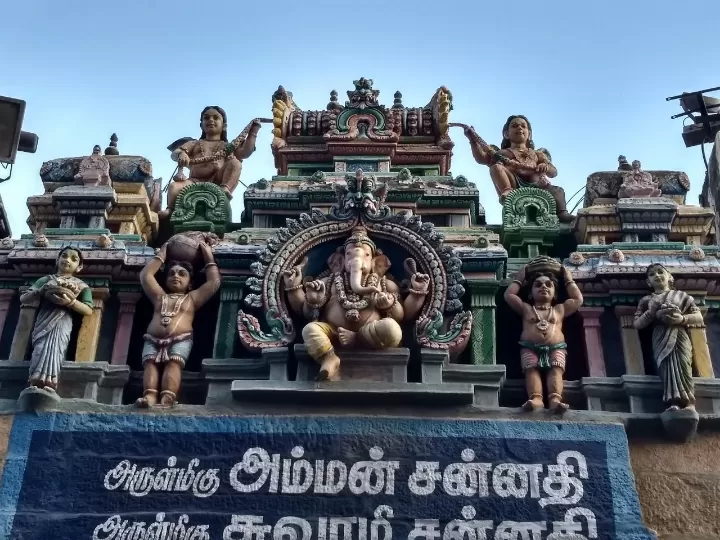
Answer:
[456, 115, 573, 223]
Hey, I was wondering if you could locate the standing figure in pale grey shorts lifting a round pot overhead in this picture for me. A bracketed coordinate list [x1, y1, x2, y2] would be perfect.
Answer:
[135, 242, 220, 408]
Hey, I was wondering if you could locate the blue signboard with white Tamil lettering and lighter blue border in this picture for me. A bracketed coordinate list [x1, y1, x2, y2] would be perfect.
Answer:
[0, 413, 654, 540]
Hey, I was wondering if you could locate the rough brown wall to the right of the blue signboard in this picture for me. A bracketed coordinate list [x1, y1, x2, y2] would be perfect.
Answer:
[630, 433, 720, 540]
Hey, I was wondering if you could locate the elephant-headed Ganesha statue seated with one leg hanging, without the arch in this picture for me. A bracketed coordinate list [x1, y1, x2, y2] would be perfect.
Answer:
[283, 227, 430, 380]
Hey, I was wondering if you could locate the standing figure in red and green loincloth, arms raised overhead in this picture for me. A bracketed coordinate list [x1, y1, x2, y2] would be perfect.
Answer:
[505, 259, 583, 414]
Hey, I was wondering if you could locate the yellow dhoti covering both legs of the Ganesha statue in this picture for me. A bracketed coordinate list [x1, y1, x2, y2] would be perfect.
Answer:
[303, 318, 402, 360]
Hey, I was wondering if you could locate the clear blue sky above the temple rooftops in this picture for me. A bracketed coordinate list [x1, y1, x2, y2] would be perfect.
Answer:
[0, 0, 720, 237]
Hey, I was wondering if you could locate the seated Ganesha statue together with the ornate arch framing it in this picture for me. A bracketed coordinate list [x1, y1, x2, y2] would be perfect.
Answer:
[238, 170, 472, 374]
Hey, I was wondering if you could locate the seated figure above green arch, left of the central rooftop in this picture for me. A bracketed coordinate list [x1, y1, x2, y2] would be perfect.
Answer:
[160, 105, 262, 217]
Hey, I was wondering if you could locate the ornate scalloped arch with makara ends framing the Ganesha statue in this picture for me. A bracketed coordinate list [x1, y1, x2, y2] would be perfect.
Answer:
[238, 171, 472, 353]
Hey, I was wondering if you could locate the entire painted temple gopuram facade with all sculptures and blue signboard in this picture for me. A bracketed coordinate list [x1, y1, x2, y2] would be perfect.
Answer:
[0, 78, 720, 540]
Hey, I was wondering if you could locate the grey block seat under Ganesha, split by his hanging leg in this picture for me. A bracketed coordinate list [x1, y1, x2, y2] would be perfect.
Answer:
[294, 345, 410, 383]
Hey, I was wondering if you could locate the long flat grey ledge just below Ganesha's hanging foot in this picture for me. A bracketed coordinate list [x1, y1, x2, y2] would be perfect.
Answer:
[232, 381, 473, 407]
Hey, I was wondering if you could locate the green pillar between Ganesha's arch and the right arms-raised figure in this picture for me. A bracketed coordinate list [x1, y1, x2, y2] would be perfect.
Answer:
[467, 280, 500, 364]
